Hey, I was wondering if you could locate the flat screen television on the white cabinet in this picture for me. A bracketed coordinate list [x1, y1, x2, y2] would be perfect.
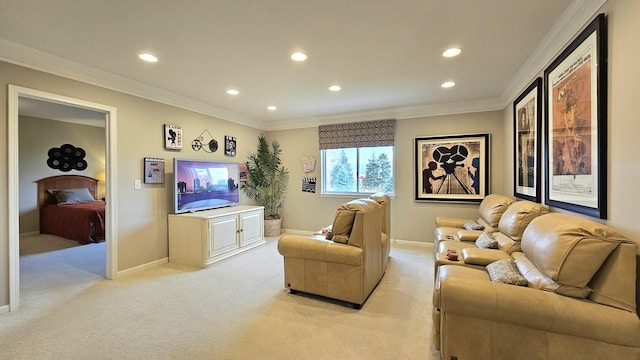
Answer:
[173, 159, 240, 214]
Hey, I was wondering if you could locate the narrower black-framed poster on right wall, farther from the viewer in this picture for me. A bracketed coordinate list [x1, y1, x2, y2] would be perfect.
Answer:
[513, 77, 542, 203]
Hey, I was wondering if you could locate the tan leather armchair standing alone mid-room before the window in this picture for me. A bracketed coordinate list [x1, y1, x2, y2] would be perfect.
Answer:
[278, 196, 390, 309]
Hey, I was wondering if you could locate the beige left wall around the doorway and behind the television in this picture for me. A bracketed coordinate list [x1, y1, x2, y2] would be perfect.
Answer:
[0, 62, 260, 306]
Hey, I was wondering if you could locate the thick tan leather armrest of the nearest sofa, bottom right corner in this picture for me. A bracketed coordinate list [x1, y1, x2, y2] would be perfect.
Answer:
[434, 265, 640, 347]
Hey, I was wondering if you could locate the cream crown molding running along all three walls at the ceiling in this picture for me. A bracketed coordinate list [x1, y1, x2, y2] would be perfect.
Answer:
[0, 0, 607, 131]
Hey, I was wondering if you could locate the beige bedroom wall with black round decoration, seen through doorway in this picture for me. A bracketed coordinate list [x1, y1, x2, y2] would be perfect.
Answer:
[18, 116, 105, 234]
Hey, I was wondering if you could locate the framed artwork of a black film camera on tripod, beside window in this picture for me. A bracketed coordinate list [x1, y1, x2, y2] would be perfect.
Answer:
[415, 134, 489, 202]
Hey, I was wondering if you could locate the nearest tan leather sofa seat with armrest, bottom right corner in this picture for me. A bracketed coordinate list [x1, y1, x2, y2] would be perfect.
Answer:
[433, 213, 640, 360]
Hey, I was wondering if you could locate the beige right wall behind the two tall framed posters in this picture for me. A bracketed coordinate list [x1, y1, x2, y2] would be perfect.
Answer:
[503, 0, 640, 246]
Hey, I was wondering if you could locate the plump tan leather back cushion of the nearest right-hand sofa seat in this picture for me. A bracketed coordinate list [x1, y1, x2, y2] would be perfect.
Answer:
[521, 213, 628, 288]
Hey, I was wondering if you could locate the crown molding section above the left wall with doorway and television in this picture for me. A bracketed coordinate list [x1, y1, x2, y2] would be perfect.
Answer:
[0, 39, 264, 129]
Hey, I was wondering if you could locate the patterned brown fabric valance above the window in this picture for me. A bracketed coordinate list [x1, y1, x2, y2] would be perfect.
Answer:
[318, 119, 396, 150]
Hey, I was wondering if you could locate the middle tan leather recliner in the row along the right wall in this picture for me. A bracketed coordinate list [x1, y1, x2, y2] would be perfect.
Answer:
[434, 200, 549, 275]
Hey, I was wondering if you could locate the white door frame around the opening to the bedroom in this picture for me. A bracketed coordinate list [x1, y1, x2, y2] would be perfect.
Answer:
[8, 85, 117, 311]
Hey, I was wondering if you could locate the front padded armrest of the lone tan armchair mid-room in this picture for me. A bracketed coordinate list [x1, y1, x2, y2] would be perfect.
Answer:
[278, 234, 362, 266]
